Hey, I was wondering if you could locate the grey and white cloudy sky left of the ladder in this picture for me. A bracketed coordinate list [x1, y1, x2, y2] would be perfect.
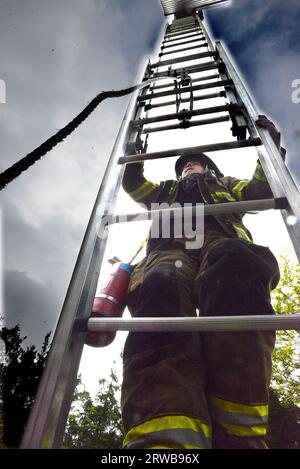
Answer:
[0, 0, 163, 350]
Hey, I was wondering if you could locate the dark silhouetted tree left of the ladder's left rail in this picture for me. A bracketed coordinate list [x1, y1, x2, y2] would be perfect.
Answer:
[0, 325, 50, 447]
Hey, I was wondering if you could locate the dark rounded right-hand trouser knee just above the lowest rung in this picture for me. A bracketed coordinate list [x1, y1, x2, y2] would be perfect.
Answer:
[199, 239, 273, 316]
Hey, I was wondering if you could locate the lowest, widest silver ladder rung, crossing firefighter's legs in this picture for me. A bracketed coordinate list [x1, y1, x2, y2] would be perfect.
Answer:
[74, 314, 300, 332]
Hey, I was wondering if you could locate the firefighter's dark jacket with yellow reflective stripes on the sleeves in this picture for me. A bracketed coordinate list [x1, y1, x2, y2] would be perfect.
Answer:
[123, 161, 272, 252]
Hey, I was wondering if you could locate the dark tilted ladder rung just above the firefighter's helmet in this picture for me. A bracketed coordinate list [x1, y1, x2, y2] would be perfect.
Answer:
[118, 137, 261, 164]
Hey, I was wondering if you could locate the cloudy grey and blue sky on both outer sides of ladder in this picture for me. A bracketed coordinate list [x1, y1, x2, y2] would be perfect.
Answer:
[0, 0, 300, 384]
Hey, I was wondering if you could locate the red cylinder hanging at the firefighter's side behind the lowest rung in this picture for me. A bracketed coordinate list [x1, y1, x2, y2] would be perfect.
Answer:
[85, 262, 133, 347]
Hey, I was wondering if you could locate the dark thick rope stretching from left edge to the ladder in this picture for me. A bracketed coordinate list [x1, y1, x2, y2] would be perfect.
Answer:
[0, 77, 170, 191]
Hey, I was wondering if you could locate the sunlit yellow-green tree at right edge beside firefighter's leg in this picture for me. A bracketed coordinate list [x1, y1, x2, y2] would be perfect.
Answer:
[268, 256, 300, 448]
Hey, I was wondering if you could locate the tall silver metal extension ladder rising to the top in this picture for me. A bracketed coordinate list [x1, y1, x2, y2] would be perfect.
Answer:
[21, 0, 300, 448]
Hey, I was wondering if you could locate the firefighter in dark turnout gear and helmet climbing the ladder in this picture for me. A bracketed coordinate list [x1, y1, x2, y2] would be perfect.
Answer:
[121, 116, 284, 449]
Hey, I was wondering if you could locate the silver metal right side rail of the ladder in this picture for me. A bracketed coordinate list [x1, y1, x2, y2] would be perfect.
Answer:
[216, 42, 300, 260]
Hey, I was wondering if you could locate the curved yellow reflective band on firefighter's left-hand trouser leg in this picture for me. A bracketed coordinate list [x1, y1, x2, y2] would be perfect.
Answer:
[123, 415, 212, 446]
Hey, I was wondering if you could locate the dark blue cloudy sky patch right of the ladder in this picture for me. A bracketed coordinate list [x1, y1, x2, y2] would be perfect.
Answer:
[207, 0, 300, 183]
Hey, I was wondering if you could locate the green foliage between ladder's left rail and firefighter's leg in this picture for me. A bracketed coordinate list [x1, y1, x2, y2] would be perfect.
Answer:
[64, 370, 123, 449]
